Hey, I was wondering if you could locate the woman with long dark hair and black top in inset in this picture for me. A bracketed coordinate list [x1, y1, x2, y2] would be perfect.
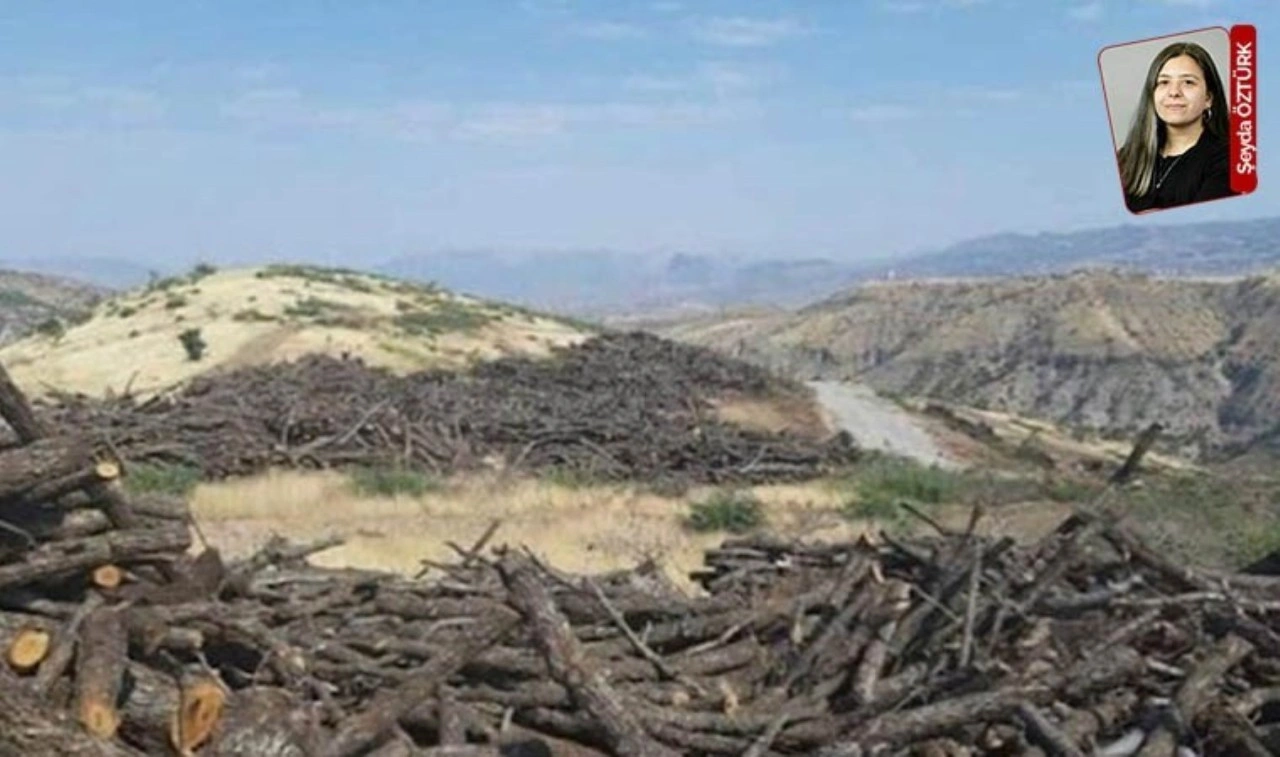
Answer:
[1116, 42, 1234, 213]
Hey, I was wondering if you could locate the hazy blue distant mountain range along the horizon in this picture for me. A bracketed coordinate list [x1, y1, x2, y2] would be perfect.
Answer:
[0, 216, 1280, 316]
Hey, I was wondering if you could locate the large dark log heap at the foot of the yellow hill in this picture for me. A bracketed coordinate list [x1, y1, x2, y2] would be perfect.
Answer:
[37, 332, 856, 485]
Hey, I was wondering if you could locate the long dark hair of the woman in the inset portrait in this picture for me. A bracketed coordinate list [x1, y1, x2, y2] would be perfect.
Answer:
[1117, 42, 1230, 196]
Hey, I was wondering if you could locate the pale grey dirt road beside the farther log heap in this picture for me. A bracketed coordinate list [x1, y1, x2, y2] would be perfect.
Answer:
[809, 382, 961, 469]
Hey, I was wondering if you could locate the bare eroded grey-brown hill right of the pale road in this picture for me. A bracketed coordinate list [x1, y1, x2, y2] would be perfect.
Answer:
[655, 272, 1280, 466]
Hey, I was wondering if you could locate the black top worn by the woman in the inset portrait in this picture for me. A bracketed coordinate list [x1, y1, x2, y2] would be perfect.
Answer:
[1125, 129, 1235, 213]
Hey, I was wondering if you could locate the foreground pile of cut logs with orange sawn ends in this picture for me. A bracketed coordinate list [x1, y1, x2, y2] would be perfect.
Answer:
[0, 363, 1280, 757]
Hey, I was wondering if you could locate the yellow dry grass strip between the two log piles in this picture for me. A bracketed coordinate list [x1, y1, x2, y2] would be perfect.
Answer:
[191, 470, 869, 590]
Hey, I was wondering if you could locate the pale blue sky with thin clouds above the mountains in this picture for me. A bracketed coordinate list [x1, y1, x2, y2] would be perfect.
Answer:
[0, 0, 1280, 264]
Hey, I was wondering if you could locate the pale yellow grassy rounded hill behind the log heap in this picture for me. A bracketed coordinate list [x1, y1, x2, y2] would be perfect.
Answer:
[0, 268, 586, 396]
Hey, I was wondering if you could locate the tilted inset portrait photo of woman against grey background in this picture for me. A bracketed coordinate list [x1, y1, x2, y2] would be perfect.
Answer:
[1098, 27, 1240, 214]
